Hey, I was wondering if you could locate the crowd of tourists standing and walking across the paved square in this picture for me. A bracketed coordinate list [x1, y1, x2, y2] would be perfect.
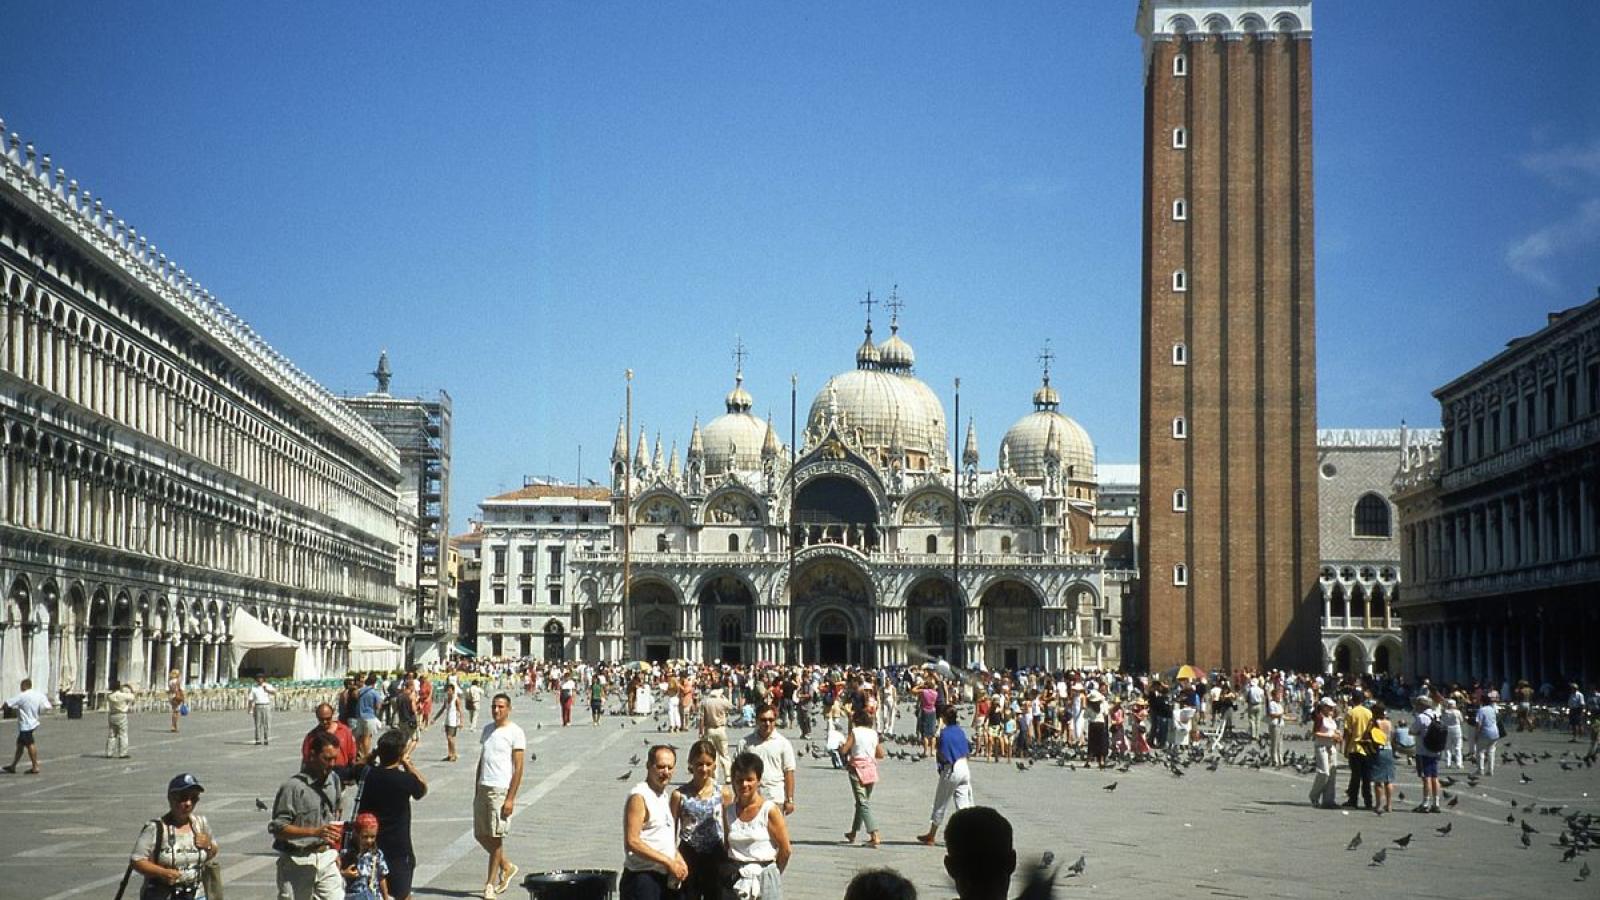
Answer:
[6, 650, 1600, 900]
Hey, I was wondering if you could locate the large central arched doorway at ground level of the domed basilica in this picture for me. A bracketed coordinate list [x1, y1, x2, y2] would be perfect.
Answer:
[790, 556, 874, 665]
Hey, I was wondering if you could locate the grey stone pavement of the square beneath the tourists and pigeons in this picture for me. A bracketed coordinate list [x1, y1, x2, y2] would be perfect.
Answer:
[0, 697, 1600, 900]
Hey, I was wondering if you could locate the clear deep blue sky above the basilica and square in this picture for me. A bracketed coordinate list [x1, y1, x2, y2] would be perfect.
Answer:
[0, 0, 1600, 530]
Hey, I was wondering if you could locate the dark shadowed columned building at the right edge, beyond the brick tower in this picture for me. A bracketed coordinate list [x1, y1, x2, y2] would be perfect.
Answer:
[1394, 296, 1600, 685]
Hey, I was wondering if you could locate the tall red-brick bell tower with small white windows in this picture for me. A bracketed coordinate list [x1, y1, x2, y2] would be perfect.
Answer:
[1136, 0, 1320, 669]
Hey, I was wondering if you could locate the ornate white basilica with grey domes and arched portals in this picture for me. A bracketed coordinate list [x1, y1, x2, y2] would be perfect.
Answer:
[570, 312, 1131, 668]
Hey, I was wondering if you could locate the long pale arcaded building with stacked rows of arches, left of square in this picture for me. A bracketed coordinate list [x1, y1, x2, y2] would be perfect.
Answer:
[0, 122, 400, 695]
